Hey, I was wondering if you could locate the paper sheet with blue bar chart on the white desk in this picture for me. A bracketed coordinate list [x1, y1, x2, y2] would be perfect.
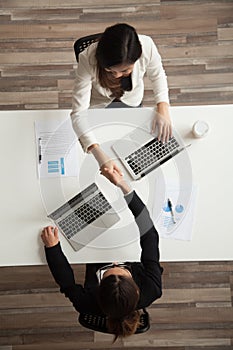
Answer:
[35, 118, 78, 178]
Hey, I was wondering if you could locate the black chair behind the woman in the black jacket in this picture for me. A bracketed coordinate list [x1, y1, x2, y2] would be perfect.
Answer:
[78, 308, 150, 334]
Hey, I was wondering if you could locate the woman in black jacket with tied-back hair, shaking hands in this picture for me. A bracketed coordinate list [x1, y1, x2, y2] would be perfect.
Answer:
[41, 169, 163, 339]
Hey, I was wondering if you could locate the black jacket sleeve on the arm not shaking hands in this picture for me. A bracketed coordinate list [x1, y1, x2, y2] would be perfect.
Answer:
[45, 243, 99, 312]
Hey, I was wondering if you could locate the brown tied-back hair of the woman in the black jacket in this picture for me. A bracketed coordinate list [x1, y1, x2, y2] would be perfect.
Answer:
[99, 275, 140, 341]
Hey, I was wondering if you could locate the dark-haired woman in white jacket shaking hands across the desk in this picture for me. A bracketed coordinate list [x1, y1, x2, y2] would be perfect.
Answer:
[71, 23, 172, 178]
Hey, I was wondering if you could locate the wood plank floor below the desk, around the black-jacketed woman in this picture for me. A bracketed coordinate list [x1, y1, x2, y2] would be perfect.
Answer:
[0, 261, 233, 350]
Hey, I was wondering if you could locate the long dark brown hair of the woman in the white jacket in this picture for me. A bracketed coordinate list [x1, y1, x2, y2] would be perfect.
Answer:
[96, 23, 142, 98]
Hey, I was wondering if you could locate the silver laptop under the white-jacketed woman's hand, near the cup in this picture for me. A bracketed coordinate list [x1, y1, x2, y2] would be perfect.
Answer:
[112, 122, 190, 180]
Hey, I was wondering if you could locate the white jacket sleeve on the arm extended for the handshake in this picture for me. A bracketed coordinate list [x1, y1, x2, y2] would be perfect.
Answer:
[70, 50, 97, 152]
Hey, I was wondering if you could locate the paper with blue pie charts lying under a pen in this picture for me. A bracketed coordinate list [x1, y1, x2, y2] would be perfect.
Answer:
[152, 184, 197, 241]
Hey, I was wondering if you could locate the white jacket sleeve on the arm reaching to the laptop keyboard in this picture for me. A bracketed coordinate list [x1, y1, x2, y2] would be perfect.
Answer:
[146, 37, 169, 104]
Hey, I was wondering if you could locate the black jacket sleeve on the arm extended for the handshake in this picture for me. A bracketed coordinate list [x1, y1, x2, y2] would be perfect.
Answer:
[125, 191, 163, 305]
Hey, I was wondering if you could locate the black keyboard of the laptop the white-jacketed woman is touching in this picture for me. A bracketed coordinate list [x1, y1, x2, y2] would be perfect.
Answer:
[125, 137, 179, 175]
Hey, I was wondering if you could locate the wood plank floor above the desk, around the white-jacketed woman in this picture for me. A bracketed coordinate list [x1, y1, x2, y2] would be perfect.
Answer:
[0, 0, 233, 110]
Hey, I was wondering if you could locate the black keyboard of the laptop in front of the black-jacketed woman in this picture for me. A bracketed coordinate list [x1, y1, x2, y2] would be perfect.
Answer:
[59, 192, 112, 239]
